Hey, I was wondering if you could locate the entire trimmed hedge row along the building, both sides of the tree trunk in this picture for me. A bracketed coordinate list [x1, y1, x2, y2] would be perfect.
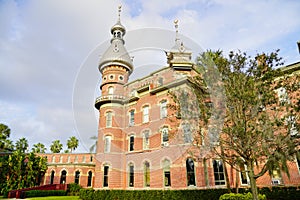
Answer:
[79, 187, 300, 200]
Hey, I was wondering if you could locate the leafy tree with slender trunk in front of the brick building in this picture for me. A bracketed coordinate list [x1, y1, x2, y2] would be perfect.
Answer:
[192, 51, 300, 199]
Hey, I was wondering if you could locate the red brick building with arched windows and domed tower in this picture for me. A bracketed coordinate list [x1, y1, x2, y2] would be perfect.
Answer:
[39, 9, 300, 189]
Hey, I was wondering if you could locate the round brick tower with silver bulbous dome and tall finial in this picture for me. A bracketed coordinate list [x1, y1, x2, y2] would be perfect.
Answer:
[95, 6, 133, 188]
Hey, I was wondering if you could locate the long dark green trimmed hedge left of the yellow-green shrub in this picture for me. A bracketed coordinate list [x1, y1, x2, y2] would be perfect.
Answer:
[79, 189, 227, 200]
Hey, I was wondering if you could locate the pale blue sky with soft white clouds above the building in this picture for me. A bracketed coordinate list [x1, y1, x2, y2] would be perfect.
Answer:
[0, 0, 300, 152]
